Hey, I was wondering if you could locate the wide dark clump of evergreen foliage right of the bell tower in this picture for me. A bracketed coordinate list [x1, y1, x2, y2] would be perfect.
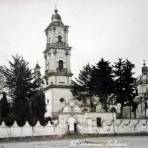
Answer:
[72, 58, 135, 111]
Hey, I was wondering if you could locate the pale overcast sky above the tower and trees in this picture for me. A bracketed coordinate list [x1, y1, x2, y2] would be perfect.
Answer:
[0, 0, 148, 77]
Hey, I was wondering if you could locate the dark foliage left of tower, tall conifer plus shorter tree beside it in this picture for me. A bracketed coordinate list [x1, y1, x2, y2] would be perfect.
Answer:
[1, 55, 45, 121]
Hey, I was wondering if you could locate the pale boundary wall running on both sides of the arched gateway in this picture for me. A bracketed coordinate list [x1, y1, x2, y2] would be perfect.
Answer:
[0, 118, 148, 138]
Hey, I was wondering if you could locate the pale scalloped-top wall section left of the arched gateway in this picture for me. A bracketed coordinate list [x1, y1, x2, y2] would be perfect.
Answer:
[0, 122, 67, 138]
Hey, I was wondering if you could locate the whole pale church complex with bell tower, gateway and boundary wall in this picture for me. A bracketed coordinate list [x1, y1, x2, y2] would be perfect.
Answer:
[0, 9, 148, 138]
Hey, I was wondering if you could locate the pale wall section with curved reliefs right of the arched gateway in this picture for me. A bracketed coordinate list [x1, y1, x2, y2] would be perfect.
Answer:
[78, 119, 148, 134]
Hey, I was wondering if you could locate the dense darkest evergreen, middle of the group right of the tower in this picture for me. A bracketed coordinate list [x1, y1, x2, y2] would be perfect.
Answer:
[92, 58, 114, 111]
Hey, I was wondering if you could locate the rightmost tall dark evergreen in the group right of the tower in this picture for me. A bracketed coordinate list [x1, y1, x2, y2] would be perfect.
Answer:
[114, 59, 135, 116]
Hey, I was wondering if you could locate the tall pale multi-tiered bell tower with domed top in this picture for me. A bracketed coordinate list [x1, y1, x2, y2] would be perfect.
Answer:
[44, 9, 72, 117]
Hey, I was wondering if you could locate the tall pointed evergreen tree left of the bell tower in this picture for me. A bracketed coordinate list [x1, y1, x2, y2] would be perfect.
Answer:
[4, 55, 37, 118]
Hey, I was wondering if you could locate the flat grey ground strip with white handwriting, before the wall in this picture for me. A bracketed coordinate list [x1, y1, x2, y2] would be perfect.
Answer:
[0, 136, 148, 148]
